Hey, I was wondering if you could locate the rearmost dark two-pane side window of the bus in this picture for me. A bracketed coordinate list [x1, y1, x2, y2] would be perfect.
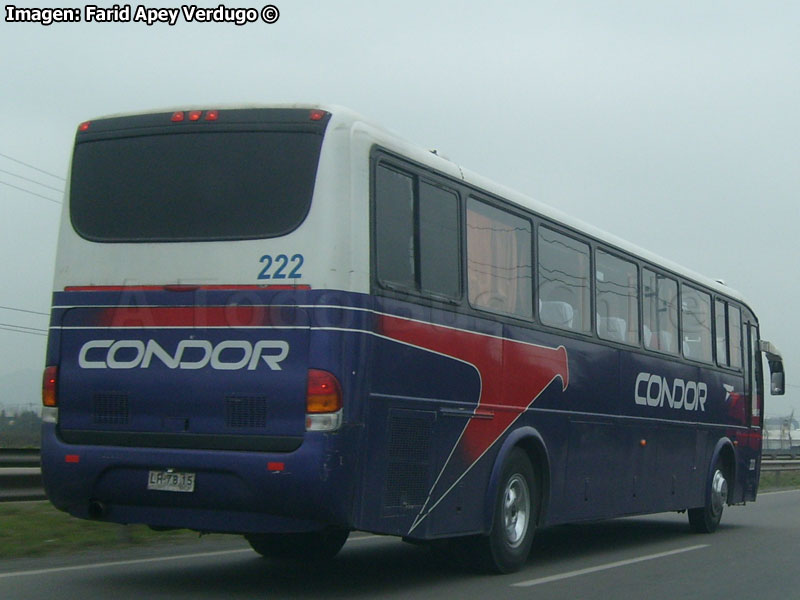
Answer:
[375, 164, 461, 298]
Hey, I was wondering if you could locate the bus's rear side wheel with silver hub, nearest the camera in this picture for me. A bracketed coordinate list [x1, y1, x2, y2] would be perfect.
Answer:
[474, 448, 539, 573]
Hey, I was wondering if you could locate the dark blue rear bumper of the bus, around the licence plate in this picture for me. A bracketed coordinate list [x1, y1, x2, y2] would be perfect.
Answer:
[42, 423, 357, 533]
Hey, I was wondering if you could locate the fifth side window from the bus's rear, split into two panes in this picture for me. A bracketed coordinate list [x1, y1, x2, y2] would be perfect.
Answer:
[642, 269, 679, 354]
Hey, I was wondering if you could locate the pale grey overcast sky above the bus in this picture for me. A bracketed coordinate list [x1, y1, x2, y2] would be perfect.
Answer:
[0, 0, 800, 416]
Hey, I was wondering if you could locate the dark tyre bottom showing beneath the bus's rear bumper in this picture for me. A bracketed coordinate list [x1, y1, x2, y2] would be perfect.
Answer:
[245, 528, 350, 560]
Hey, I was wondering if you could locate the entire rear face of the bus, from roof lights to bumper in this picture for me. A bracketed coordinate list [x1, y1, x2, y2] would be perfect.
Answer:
[42, 108, 367, 532]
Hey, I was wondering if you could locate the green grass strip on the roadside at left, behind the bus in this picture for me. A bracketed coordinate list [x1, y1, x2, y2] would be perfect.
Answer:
[0, 502, 214, 559]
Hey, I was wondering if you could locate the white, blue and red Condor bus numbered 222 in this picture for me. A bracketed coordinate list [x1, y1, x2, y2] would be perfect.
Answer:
[42, 105, 784, 572]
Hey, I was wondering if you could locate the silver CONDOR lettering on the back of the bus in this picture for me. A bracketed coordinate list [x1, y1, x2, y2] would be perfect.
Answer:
[78, 340, 289, 371]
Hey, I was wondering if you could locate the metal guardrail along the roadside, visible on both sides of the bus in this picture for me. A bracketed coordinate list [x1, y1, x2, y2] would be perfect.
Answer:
[0, 448, 800, 502]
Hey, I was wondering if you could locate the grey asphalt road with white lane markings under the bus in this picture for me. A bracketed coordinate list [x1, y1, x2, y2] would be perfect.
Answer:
[0, 490, 800, 600]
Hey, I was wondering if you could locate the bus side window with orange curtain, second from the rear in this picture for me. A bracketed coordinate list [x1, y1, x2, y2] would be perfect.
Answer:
[467, 198, 533, 319]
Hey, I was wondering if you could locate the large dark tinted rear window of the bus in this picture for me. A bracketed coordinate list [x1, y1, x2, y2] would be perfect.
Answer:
[70, 131, 322, 242]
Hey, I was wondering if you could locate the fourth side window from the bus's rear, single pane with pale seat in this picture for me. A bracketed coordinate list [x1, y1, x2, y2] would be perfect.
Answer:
[595, 250, 639, 345]
